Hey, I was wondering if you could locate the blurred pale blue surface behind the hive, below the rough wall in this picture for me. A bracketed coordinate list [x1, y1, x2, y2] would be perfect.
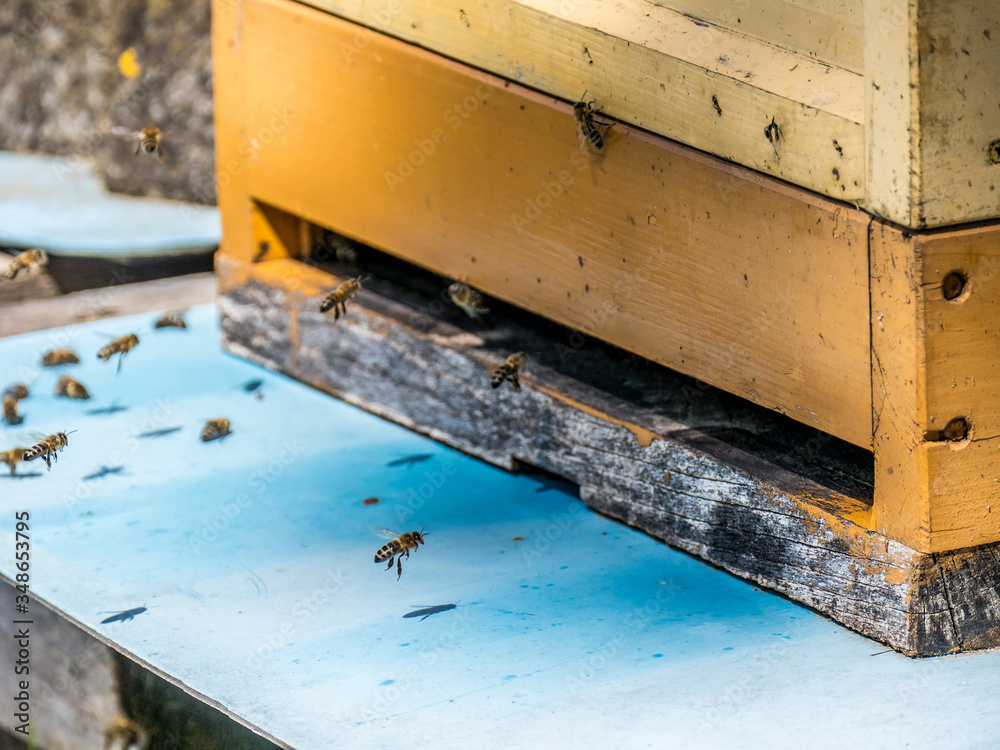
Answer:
[0, 151, 221, 259]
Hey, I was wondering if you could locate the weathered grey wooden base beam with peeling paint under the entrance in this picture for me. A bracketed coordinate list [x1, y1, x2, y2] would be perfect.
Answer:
[218, 256, 1000, 655]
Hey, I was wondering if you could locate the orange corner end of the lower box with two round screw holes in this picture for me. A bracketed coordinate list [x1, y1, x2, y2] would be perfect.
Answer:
[872, 225, 1000, 552]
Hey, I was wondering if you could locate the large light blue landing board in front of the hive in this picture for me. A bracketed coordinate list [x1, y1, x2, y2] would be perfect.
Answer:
[0, 307, 1000, 749]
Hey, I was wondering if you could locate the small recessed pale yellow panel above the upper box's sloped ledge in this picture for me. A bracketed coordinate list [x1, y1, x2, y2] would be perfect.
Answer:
[654, 0, 865, 74]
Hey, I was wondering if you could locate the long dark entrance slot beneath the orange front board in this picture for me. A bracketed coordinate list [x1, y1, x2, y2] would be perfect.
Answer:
[307, 230, 875, 506]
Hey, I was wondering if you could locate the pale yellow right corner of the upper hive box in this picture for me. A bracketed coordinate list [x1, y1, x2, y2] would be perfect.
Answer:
[865, 0, 1000, 227]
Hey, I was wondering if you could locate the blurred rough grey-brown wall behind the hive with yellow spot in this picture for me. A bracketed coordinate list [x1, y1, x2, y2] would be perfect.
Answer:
[0, 0, 215, 203]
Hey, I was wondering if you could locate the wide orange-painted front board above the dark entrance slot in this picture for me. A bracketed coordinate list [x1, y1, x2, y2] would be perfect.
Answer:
[227, 0, 871, 446]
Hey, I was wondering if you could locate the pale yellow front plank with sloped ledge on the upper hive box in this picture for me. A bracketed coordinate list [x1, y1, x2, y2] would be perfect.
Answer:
[298, 0, 865, 201]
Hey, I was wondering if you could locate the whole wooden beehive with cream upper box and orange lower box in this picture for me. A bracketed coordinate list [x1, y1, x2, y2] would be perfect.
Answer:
[213, 0, 1000, 655]
